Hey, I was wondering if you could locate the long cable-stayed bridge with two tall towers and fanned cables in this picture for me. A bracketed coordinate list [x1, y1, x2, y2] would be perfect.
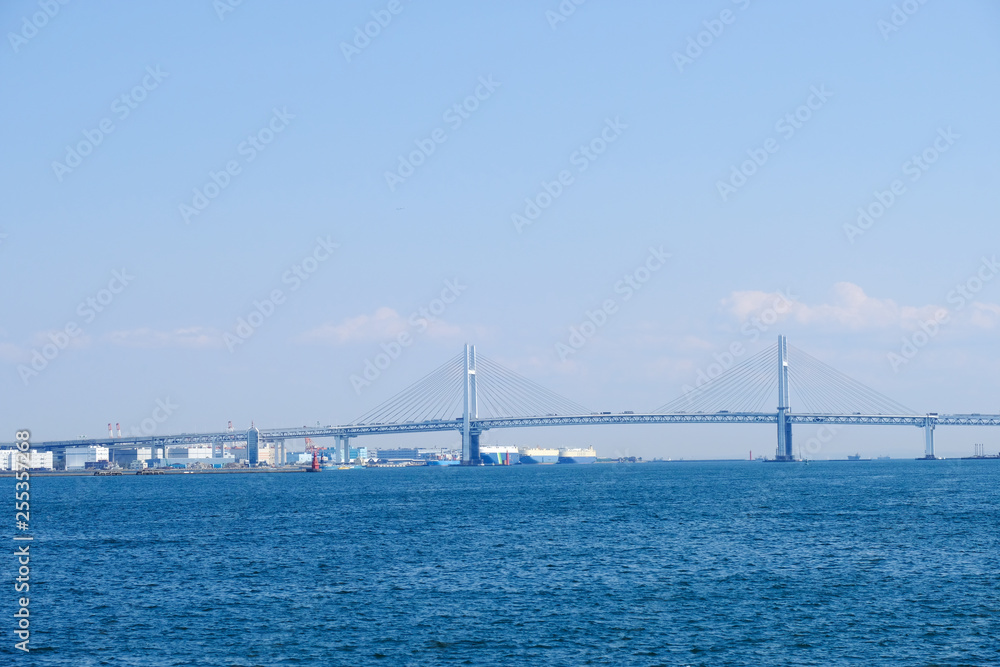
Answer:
[27, 336, 1000, 464]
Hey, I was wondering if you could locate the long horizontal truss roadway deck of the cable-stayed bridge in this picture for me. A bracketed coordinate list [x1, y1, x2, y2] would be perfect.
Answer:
[19, 412, 1000, 450]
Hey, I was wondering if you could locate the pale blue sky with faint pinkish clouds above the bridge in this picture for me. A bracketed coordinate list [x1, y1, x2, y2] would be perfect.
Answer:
[0, 0, 1000, 458]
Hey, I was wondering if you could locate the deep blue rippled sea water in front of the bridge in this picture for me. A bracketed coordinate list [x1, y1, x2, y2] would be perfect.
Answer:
[7, 460, 1000, 667]
